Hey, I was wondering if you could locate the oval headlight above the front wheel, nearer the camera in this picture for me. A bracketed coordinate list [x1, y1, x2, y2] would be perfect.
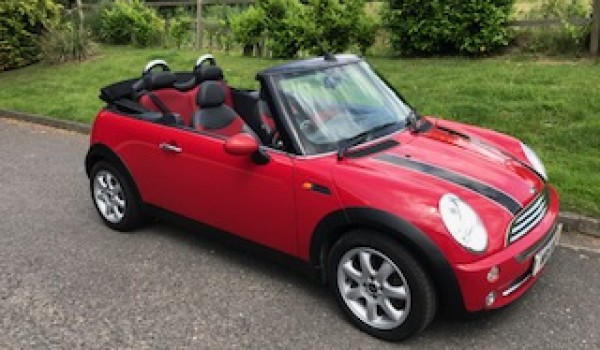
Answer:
[440, 193, 488, 253]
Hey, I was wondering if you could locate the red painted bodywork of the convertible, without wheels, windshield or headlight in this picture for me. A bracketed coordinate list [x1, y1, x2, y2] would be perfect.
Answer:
[86, 55, 560, 340]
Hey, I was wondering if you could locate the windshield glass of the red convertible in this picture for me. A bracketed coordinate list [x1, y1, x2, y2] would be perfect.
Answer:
[276, 62, 411, 155]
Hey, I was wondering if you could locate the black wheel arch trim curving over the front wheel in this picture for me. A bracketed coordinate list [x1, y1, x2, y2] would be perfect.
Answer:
[309, 208, 466, 314]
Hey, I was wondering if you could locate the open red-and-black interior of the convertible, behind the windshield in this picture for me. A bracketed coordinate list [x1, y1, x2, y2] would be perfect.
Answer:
[100, 55, 283, 148]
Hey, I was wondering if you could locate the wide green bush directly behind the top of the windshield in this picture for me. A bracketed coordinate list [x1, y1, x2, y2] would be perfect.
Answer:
[231, 0, 376, 58]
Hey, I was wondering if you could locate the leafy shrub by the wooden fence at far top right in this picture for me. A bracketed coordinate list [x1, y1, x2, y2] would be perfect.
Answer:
[517, 0, 591, 55]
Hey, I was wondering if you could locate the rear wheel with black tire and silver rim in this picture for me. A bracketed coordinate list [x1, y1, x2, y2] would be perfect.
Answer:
[90, 161, 145, 232]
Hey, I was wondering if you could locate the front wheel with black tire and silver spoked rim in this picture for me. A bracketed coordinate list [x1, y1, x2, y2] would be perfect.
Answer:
[326, 230, 437, 341]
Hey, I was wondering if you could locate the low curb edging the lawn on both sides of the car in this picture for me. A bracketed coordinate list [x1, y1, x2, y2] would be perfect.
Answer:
[0, 109, 600, 237]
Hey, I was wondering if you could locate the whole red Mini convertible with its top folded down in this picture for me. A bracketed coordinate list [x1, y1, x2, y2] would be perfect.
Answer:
[85, 55, 561, 340]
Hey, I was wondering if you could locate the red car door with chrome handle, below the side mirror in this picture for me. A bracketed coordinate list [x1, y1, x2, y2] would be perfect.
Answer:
[123, 121, 296, 254]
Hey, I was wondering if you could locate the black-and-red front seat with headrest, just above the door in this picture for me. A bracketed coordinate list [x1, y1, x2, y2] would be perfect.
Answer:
[192, 81, 245, 137]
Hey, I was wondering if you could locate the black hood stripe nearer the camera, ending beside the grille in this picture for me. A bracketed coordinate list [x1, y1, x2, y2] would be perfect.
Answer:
[374, 154, 522, 215]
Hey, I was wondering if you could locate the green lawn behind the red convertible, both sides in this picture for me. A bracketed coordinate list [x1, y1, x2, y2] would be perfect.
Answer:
[0, 47, 600, 217]
